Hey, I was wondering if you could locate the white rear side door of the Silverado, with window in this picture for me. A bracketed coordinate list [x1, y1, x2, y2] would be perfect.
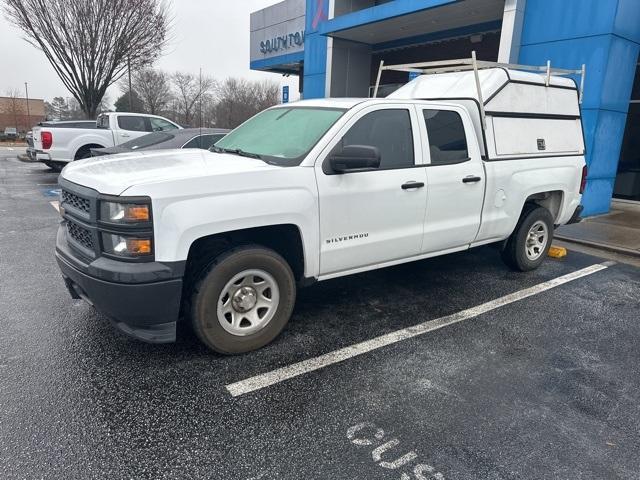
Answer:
[416, 106, 486, 253]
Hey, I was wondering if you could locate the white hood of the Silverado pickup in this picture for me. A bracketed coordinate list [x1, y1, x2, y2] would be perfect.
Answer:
[61, 149, 280, 195]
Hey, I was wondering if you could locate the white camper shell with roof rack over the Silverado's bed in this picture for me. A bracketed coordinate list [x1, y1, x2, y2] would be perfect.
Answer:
[381, 58, 585, 160]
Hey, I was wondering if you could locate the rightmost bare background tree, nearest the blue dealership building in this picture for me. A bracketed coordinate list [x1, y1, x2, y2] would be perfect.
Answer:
[215, 78, 280, 128]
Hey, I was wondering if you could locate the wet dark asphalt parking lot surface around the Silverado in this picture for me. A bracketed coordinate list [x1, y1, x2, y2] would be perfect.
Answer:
[0, 150, 640, 480]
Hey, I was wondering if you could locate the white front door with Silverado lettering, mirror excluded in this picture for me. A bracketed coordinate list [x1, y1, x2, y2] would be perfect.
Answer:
[316, 104, 427, 275]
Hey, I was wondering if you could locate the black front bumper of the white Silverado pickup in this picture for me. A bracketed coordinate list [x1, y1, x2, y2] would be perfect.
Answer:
[56, 224, 184, 343]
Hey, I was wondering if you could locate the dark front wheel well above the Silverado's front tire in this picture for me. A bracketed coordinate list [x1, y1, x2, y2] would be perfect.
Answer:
[186, 224, 304, 281]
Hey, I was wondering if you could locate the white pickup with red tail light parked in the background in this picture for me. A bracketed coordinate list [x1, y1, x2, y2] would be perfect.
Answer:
[33, 112, 182, 170]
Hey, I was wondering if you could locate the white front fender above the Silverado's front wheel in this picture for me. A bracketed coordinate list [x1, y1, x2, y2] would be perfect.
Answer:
[138, 168, 319, 277]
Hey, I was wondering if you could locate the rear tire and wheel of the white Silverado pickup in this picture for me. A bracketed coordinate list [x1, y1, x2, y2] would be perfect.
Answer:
[502, 204, 553, 272]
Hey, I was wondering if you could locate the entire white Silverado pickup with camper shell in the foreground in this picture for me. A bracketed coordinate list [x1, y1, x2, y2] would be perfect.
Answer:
[56, 60, 586, 354]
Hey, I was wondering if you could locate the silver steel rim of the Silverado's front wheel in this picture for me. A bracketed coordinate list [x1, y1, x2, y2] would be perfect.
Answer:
[217, 269, 280, 337]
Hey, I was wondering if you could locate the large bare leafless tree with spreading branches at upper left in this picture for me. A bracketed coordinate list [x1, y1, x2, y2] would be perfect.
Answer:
[4, 0, 170, 118]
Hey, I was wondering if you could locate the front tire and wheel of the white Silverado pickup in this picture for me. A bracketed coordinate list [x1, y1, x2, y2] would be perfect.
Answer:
[188, 245, 296, 355]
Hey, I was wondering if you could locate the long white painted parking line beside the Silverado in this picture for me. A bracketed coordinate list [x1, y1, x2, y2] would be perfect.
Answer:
[226, 262, 615, 397]
